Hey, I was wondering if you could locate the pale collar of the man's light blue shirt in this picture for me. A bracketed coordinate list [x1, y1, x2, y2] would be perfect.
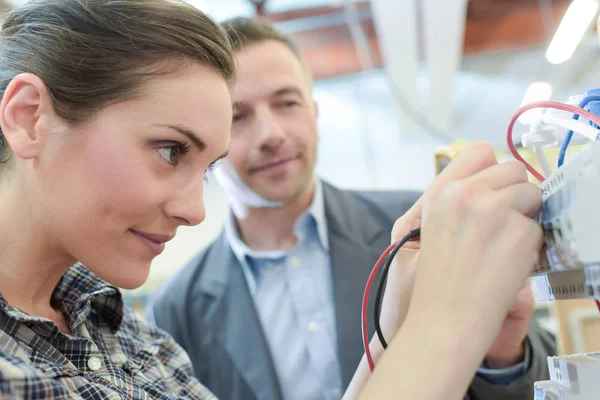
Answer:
[225, 178, 329, 265]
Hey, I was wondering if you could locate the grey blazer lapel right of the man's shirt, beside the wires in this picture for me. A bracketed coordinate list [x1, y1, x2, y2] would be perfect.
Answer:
[323, 184, 389, 387]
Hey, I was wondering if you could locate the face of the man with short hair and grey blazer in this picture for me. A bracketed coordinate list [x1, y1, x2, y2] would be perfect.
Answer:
[228, 40, 318, 201]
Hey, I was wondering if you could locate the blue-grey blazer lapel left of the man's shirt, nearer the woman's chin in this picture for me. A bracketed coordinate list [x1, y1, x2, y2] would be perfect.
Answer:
[196, 235, 281, 400]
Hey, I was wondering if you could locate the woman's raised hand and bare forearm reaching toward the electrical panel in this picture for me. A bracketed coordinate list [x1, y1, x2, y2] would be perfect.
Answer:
[345, 143, 542, 400]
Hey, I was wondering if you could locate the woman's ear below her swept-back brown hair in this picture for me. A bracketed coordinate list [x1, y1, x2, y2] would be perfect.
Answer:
[0, 74, 54, 159]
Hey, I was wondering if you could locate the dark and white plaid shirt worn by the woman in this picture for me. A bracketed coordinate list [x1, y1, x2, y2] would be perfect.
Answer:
[0, 264, 215, 400]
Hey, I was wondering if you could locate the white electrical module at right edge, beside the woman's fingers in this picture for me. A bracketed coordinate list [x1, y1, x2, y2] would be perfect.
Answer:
[532, 141, 600, 300]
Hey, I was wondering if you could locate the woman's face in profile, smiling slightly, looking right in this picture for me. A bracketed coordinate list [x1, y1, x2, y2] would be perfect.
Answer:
[19, 65, 232, 288]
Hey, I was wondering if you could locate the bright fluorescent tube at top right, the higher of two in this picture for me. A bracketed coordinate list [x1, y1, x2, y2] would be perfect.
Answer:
[546, 0, 598, 64]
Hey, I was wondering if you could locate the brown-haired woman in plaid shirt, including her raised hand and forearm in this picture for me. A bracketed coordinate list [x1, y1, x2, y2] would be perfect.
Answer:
[0, 0, 540, 399]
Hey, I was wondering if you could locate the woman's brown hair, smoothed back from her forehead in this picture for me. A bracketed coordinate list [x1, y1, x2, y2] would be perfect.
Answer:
[0, 0, 235, 163]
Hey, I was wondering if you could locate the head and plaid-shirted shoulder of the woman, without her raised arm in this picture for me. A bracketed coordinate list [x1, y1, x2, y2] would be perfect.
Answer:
[0, 0, 235, 399]
